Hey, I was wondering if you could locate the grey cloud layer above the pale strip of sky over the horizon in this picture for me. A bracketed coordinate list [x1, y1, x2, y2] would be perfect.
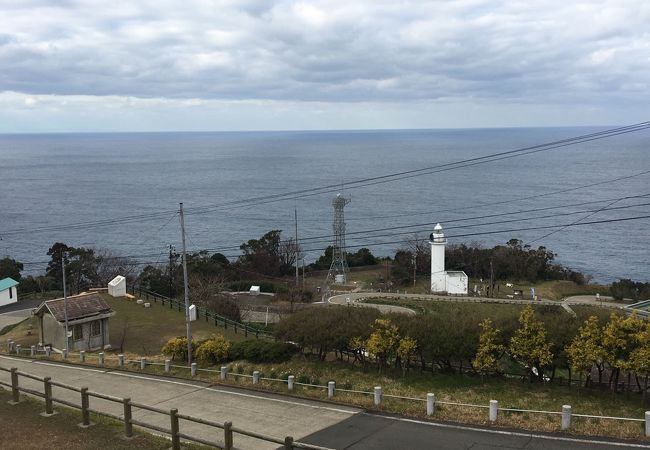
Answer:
[0, 0, 650, 129]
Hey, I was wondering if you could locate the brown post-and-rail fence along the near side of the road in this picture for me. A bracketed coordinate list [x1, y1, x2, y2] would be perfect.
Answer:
[0, 366, 333, 450]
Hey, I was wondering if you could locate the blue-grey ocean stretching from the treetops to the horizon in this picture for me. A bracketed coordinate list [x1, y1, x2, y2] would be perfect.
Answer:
[0, 128, 650, 282]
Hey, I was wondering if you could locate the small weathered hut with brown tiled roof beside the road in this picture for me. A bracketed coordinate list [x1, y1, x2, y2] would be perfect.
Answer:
[34, 293, 115, 351]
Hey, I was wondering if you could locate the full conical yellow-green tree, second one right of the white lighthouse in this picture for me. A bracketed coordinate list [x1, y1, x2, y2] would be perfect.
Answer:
[509, 305, 553, 381]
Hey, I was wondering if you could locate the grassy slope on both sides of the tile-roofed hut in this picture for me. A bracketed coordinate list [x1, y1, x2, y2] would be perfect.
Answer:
[2, 295, 253, 356]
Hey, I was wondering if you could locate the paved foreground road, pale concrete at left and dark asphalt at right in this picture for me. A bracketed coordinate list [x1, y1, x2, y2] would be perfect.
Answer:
[0, 356, 650, 450]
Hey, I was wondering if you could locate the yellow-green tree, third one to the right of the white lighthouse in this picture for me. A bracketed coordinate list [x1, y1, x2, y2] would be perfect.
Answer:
[566, 316, 605, 387]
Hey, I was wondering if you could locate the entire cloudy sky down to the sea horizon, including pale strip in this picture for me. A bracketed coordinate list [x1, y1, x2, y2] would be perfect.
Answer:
[0, 0, 650, 133]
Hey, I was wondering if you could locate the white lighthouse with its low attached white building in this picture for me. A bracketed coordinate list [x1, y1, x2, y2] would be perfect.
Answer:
[429, 224, 469, 295]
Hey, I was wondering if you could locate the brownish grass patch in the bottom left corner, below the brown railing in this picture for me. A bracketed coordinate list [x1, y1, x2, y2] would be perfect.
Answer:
[0, 389, 207, 450]
